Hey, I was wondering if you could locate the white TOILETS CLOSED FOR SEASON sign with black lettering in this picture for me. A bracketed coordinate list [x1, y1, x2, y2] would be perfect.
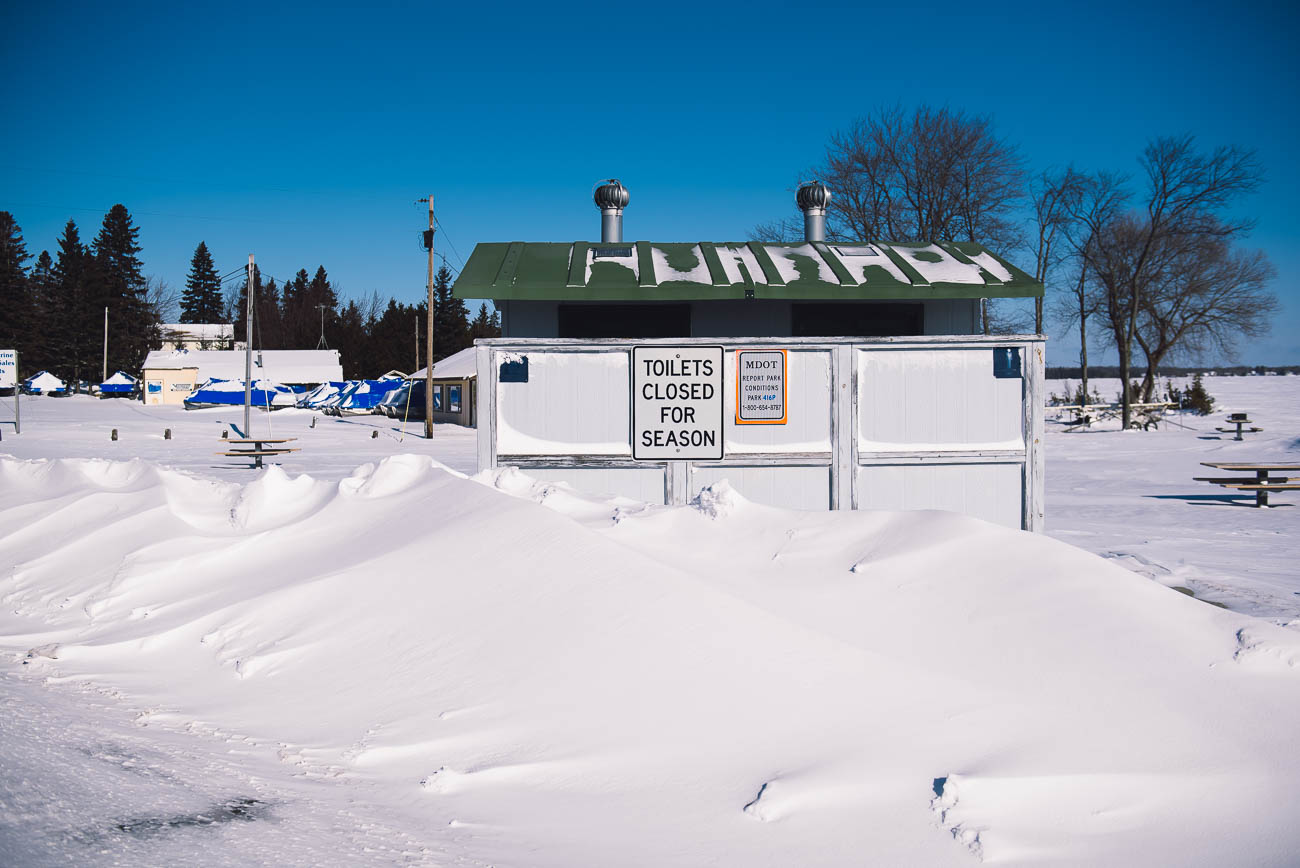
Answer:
[632, 346, 723, 461]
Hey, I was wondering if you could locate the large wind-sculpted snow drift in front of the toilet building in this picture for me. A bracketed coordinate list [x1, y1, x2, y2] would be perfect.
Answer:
[0, 455, 1300, 865]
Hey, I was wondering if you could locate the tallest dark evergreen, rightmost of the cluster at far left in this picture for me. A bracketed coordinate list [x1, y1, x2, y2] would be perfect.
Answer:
[87, 204, 154, 376]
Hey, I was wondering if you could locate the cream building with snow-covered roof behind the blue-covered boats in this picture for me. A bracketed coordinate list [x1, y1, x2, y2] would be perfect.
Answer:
[140, 350, 343, 404]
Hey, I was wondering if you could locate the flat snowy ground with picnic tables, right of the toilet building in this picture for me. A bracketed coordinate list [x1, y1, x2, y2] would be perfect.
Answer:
[1047, 377, 1300, 626]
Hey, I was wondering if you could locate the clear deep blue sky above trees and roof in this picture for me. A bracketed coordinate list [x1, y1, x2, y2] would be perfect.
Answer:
[0, 0, 1300, 364]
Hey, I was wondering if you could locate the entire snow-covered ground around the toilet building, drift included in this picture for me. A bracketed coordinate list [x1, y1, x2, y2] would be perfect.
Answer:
[0, 387, 1300, 867]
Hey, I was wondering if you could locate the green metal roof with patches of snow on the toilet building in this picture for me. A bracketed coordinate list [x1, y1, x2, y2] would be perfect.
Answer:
[452, 242, 1043, 301]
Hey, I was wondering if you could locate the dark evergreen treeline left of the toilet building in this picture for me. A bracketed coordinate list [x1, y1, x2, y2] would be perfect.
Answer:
[0, 204, 501, 383]
